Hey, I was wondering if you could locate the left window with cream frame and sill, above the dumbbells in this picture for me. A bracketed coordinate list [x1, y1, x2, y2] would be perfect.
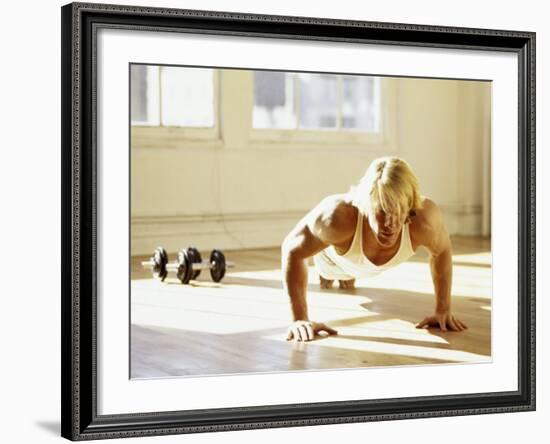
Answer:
[130, 65, 218, 145]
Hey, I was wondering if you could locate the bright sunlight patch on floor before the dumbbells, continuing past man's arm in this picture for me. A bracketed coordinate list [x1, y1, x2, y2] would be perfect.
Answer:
[131, 279, 378, 334]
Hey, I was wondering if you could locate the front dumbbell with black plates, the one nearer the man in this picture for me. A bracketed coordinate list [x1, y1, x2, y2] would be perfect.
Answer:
[166, 247, 235, 284]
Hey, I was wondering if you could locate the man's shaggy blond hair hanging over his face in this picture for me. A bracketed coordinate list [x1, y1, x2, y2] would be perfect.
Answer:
[350, 157, 422, 217]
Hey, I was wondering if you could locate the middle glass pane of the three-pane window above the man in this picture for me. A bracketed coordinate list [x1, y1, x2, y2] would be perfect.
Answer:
[298, 74, 338, 129]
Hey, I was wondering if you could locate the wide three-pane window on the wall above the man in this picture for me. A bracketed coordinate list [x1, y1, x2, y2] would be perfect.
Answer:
[252, 71, 382, 135]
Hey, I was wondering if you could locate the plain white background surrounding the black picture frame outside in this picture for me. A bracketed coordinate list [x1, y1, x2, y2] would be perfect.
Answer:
[0, 0, 550, 444]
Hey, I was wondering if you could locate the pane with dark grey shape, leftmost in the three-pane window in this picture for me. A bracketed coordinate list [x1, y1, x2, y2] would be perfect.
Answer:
[252, 71, 296, 129]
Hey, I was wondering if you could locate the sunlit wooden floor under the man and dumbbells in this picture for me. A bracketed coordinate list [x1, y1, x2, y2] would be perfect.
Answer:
[131, 238, 491, 378]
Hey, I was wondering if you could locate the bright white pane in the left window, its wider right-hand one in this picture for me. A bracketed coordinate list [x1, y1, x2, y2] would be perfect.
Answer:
[161, 67, 214, 128]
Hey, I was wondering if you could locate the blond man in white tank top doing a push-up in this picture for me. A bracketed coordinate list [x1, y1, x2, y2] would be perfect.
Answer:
[281, 157, 467, 341]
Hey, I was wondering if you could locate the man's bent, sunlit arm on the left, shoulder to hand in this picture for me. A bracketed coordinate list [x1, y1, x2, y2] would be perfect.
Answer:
[281, 198, 356, 341]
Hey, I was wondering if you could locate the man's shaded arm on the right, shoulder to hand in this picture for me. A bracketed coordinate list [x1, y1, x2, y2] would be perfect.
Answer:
[417, 200, 467, 331]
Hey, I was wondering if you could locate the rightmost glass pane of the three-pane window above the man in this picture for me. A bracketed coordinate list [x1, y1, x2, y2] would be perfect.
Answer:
[342, 76, 380, 132]
